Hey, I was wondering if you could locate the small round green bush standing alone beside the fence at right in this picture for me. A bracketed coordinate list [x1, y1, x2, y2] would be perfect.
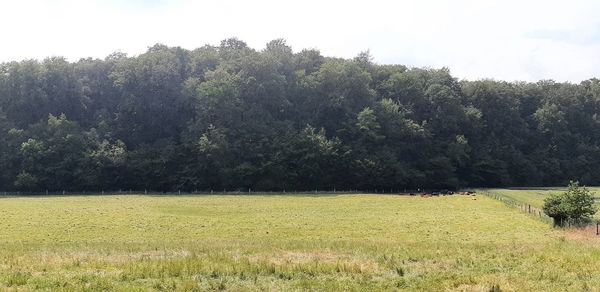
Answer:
[544, 181, 596, 226]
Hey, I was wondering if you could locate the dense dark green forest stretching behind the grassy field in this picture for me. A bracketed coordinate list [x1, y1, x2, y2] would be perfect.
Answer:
[0, 38, 600, 191]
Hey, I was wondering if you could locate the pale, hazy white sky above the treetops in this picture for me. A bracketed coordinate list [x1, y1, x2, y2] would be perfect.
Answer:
[0, 0, 600, 83]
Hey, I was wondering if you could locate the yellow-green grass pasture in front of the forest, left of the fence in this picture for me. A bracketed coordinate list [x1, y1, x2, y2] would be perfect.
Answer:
[0, 195, 600, 291]
